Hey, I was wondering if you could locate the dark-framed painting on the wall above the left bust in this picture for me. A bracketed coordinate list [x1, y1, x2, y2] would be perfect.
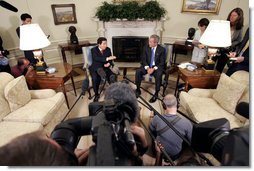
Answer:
[51, 4, 77, 25]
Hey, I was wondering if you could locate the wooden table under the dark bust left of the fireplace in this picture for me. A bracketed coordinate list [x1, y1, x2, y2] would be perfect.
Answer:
[58, 41, 96, 63]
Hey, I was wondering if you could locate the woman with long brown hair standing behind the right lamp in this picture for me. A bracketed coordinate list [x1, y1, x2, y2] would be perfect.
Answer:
[215, 8, 244, 72]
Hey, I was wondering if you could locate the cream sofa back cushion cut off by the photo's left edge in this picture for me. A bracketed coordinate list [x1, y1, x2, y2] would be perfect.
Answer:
[0, 72, 14, 120]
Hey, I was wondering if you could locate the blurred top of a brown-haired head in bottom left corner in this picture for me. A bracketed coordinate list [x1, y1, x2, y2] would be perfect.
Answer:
[0, 131, 78, 166]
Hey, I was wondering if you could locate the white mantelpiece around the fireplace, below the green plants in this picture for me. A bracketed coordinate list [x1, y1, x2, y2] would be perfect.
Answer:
[95, 19, 165, 49]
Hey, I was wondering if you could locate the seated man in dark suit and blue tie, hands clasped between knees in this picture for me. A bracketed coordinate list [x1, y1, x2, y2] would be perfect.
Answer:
[135, 35, 166, 103]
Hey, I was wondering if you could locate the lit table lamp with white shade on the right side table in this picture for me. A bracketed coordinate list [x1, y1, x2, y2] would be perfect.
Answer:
[199, 20, 231, 70]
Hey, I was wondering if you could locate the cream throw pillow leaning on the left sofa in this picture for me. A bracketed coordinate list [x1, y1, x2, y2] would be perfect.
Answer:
[4, 75, 31, 112]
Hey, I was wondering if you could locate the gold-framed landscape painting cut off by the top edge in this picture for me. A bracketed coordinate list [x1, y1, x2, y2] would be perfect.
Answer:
[182, 0, 221, 14]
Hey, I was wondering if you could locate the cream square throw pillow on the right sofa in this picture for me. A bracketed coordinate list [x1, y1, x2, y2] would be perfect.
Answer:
[213, 73, 245, 114]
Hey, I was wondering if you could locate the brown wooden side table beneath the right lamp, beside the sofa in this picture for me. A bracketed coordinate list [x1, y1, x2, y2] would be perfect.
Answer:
[175, 68, 220, 96]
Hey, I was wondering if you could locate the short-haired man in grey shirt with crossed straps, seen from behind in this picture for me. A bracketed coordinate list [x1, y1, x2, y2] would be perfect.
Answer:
[149, 94, 192, 160]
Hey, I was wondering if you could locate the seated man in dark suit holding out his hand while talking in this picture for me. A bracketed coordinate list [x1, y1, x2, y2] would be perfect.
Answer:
[89, 37, 116, 101]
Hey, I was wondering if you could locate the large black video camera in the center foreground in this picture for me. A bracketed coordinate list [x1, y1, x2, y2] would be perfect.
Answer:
[51, 100, 142, 166]
